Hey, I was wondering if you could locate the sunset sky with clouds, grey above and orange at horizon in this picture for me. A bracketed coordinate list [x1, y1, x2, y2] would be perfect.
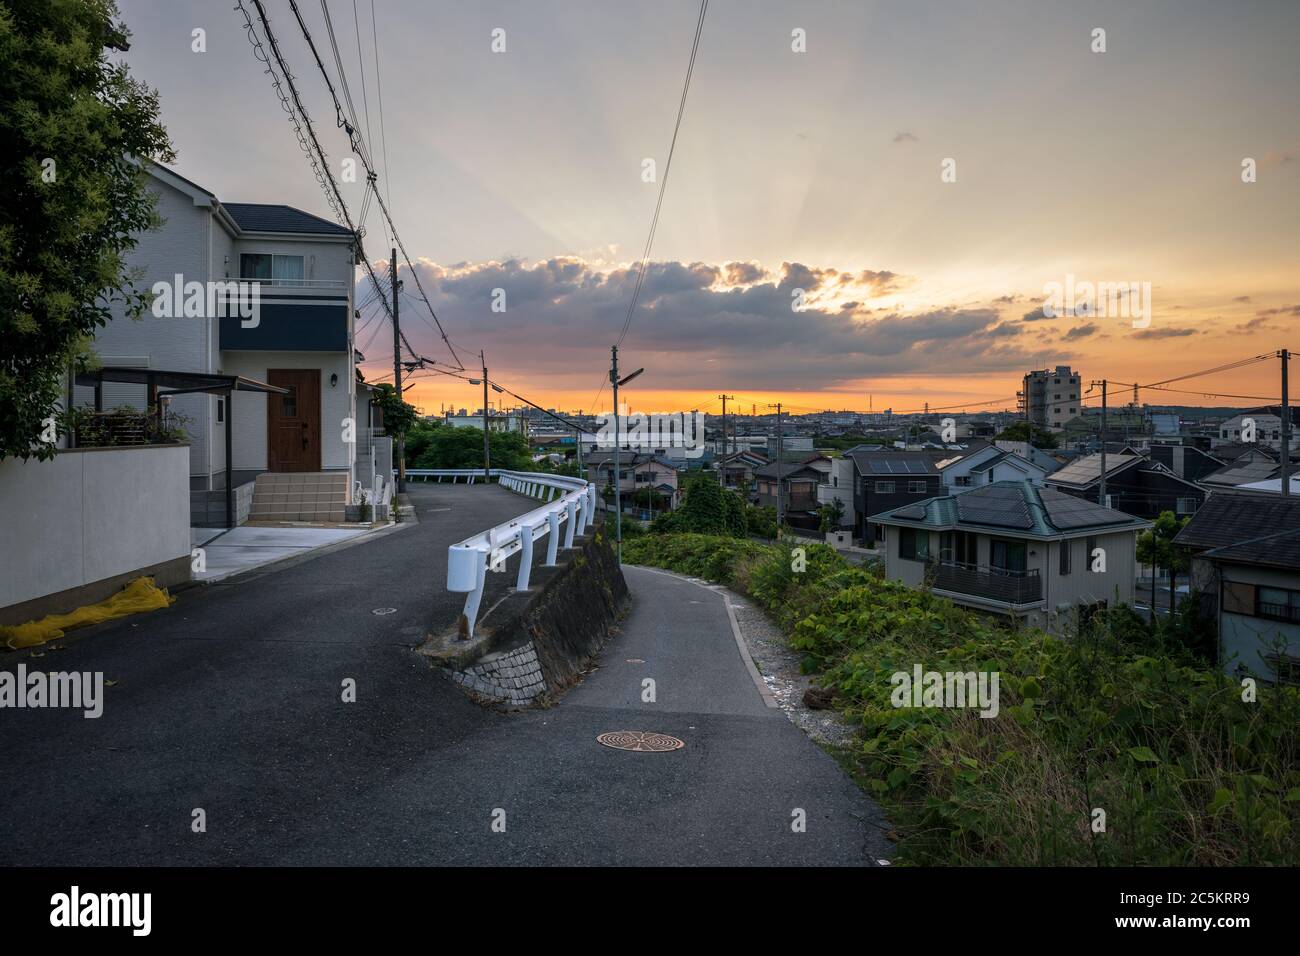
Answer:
[120, 0, 1300, 412]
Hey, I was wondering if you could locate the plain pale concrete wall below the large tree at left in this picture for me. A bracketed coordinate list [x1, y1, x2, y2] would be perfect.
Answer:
[0, 445, 190, 624]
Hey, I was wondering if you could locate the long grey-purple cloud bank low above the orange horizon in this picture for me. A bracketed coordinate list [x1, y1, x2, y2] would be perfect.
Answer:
[379, 256, 1050, 392]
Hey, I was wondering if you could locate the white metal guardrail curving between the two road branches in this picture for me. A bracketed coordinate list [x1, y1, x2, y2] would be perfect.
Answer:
[406, 468, 595, 637]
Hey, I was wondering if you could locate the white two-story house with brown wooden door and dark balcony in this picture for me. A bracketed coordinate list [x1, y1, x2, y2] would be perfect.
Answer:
[77, 165, 365, 524]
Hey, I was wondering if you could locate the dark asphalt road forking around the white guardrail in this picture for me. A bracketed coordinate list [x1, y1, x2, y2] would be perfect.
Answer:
[0, 485, 888, 866]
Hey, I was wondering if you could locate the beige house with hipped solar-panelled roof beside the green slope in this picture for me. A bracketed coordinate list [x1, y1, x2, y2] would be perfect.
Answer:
[870, 480, 1151, 631]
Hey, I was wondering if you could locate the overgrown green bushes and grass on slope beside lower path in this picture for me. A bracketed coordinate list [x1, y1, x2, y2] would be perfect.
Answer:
[623, 535, 1300, 866]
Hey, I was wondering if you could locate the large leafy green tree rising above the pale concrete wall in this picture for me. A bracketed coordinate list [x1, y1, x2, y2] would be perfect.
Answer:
[0, 0, 174, 459]
